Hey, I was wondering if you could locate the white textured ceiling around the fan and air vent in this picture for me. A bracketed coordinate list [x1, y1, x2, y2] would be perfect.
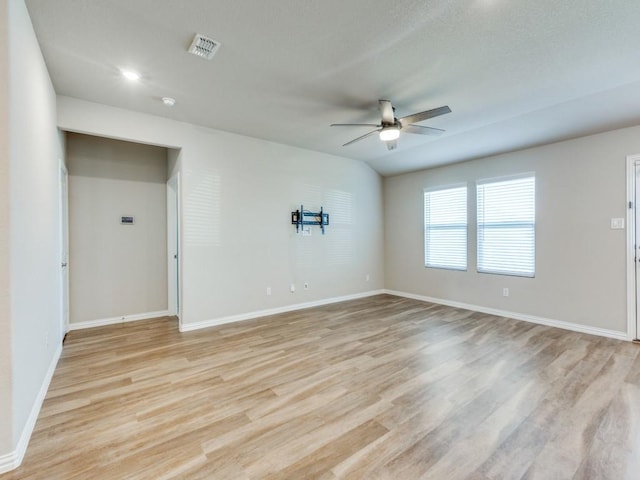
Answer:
[26, 0, 640, 175]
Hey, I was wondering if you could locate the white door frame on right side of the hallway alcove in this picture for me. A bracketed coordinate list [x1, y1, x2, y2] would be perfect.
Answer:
[167, 172, 182, 326]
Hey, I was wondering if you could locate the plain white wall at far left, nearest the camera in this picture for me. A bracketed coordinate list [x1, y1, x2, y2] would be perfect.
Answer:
[0, 0, 63, 468]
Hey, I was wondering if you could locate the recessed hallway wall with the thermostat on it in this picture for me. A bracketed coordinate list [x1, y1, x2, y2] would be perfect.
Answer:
[67, 133, 167, 328]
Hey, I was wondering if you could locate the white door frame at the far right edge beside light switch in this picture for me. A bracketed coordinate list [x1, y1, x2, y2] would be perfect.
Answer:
[627, 154, 640, 340]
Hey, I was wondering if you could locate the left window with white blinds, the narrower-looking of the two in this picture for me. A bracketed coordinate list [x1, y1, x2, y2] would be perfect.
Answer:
[424, 185, 467, 270]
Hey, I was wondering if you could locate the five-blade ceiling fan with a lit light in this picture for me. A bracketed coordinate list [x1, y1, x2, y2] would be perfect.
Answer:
[331, 100, 451, 150]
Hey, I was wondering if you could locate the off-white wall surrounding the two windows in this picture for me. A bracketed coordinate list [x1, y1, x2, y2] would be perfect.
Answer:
[385, 127, 640, 332]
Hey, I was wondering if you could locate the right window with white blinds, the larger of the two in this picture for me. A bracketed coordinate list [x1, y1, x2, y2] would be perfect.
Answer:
[477, 174, 536, 277]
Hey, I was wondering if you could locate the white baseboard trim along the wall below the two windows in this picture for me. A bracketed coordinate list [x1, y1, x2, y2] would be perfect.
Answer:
[384, 290, 629, 341]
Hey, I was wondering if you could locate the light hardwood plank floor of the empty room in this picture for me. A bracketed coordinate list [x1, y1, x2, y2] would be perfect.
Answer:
[0, 295, 640, 480]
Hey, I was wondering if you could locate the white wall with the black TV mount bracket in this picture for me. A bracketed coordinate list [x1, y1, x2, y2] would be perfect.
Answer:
[58, 97, 383, 327]
